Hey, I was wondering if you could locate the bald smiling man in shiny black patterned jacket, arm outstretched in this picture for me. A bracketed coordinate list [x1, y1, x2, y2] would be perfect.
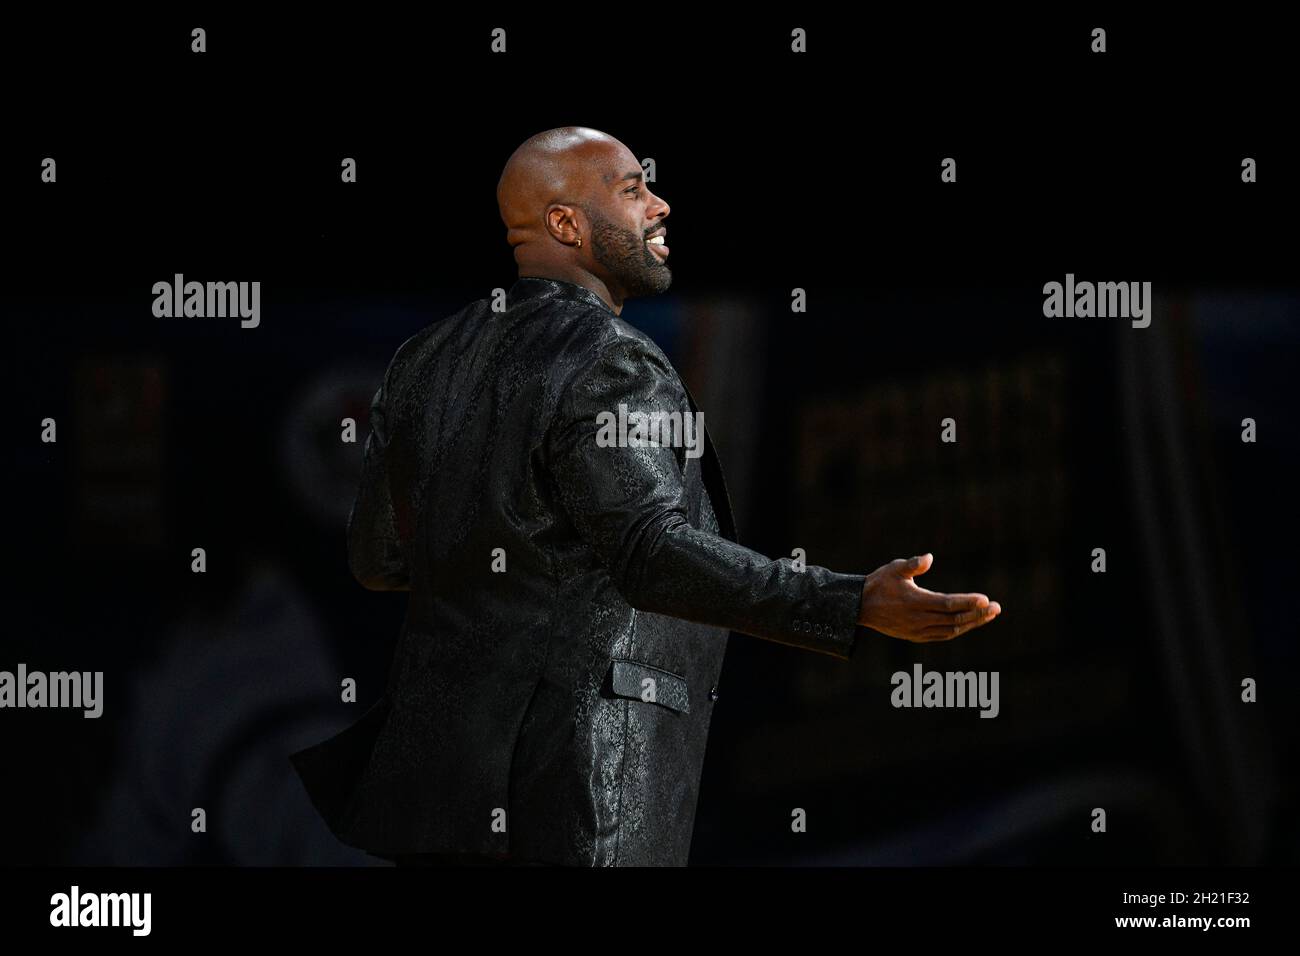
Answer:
[293, 127, 1000, 866]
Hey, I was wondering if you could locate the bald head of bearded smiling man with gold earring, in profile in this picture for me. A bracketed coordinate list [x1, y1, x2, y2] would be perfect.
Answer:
[497, 126, 672, 312]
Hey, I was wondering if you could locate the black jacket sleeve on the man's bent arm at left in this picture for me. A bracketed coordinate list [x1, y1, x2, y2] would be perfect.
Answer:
[347, 364, 411, 591]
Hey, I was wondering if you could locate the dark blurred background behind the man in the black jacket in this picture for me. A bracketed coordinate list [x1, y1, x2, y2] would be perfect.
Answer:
[0, 13, 1300, 865]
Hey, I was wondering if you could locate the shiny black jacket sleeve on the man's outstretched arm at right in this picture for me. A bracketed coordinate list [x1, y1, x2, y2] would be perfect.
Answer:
[547, 329, 866, 659]
